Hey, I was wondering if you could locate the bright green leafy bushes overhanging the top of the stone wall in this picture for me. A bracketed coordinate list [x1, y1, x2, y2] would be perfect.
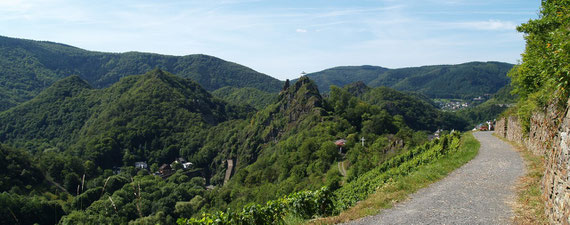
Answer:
[509, 0, 570, 131]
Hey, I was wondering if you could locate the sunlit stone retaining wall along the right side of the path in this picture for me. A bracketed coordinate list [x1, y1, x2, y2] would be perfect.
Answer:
[496, 99, 570, 224]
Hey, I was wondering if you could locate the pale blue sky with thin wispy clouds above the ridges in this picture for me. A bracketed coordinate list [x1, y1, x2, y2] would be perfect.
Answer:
[0, 0, 540, 80]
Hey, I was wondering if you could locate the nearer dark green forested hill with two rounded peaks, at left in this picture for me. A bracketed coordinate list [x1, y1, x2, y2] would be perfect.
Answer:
[0, 69, 253, 160]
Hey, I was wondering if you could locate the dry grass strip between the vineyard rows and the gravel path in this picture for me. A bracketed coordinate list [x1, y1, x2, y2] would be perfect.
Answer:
[307, 133, 480, 224]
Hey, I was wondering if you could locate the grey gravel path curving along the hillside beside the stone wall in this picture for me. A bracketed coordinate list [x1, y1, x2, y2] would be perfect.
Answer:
[347, 132, 525, 224]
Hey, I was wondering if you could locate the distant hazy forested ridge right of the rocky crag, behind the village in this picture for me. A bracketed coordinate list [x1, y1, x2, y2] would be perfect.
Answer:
[307, 62, 513, 98]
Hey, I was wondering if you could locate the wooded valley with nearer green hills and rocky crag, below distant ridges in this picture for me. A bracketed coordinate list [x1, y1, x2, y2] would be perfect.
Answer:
[0, 46, 500, 224]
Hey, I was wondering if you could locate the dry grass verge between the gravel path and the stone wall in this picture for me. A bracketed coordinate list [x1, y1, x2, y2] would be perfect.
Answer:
[490, 134, 548, 224]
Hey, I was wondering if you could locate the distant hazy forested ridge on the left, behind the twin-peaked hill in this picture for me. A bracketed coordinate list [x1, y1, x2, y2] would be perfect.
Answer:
[0, 36, 282, 111]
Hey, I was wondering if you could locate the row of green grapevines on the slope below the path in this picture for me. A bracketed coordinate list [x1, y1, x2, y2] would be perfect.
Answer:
[177, 132, 461, 225]
